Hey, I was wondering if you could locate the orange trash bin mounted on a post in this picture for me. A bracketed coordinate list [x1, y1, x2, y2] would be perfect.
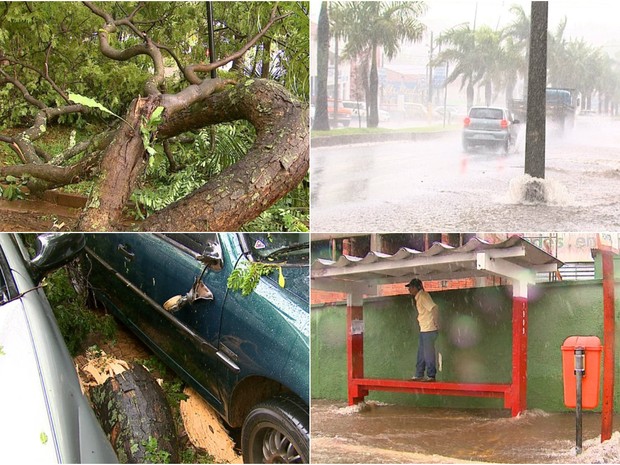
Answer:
[562, 336, 603, 409]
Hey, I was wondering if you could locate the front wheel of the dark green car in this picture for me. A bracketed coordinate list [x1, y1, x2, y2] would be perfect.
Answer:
[241, 397, 309, 463]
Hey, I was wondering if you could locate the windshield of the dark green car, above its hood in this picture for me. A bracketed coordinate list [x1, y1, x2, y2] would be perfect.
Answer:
[244, 233, 310, 264]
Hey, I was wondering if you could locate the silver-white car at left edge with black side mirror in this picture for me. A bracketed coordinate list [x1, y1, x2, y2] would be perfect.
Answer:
[0, 233, 117, 463]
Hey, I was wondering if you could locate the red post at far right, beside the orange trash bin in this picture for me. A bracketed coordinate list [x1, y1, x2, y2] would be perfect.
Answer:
[601, 251, 616, 442]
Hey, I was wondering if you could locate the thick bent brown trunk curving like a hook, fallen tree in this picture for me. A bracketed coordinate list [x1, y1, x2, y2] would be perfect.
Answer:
[140, 80, 310, 231]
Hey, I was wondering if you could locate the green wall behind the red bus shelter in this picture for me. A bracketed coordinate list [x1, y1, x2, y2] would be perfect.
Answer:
[311, 280, 620, 411]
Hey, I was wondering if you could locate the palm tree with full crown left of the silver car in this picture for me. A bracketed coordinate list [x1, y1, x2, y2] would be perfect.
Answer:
[336, 1, 426, 127]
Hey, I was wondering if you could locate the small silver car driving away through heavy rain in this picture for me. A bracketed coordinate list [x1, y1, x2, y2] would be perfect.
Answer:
[463, 107, 520, 153]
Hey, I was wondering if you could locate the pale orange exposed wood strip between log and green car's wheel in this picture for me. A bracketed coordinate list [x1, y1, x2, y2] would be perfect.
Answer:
[180, 388, 243, 463]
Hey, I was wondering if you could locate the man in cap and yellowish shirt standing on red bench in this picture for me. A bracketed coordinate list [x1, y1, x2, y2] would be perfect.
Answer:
[405, 278, 439, 382]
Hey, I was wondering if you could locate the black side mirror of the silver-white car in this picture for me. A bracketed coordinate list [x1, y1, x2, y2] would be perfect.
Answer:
[28, 233, 86, 283]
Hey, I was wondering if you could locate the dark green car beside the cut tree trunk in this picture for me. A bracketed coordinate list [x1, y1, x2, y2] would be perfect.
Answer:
[85, 233, 310, 463]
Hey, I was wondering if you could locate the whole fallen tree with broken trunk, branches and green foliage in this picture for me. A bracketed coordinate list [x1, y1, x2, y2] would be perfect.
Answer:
[0, 2, 309, 231]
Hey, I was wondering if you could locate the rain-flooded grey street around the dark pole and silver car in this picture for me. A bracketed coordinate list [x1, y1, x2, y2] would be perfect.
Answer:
[311, 115, 620, 232]
